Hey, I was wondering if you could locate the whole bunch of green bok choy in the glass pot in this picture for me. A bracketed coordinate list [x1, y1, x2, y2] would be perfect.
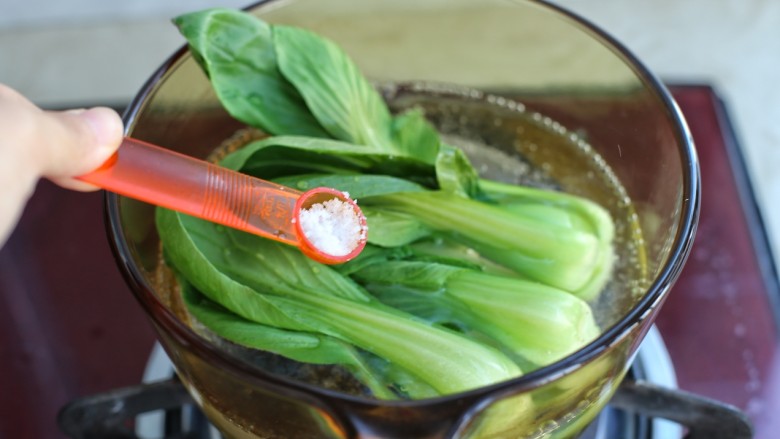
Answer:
[165, 9, 614, 404]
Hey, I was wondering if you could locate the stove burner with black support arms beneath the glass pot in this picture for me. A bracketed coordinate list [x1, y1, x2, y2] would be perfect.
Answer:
[59, 327, 752, 439]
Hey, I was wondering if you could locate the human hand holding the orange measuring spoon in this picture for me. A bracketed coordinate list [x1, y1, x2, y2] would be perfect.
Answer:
[0, 84, 123, 245]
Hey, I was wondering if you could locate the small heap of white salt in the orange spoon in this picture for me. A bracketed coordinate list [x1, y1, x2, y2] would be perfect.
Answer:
[299, 198, 366, 256]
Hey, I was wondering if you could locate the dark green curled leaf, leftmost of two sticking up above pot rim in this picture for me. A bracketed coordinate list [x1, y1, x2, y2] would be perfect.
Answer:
[173, 8, 329, 137]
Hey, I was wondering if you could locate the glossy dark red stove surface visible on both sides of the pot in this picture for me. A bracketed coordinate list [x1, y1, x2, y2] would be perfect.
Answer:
[0, 86, 780, 439]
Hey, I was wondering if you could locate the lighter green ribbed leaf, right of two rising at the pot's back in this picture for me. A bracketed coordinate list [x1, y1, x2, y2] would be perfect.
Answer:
[273, 26, 397, 153]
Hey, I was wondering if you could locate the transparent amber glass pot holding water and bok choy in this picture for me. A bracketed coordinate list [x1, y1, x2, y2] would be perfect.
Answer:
[107, 0, 699, 438]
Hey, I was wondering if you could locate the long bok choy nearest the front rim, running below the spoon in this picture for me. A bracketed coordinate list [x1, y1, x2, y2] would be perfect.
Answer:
[157, 209, 521, 394]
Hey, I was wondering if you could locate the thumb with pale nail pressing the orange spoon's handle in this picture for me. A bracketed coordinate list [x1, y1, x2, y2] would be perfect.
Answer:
[34, 107, 122, 190]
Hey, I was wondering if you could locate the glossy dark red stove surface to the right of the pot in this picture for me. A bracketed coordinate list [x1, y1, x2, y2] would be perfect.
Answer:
[657, 86, 780, 439]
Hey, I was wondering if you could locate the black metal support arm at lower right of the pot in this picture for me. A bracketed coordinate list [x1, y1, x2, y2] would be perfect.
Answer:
[610, 379, 753, 439]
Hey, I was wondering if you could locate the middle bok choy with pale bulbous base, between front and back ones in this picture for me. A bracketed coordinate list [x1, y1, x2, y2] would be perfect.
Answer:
[352, 260, 599, 365]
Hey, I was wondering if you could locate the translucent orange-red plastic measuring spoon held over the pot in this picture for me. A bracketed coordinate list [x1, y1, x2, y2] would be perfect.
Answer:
[78, 137, 366, 264]
